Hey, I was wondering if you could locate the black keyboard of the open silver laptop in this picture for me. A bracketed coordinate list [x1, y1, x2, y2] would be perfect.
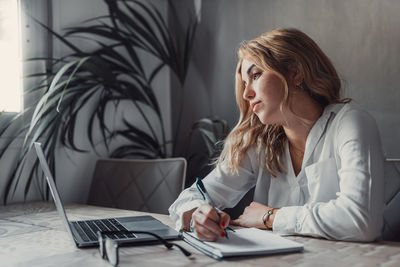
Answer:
[71, 219, 136, 242]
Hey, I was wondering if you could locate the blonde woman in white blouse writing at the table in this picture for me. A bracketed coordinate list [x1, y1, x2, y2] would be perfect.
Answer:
[169, 29, 384, 244]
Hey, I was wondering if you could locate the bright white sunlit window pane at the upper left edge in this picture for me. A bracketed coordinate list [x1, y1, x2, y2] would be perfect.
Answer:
[0, 0, 22, 112]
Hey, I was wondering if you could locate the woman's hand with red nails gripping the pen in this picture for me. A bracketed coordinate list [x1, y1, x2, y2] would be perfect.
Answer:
[192, 204, 231, 241]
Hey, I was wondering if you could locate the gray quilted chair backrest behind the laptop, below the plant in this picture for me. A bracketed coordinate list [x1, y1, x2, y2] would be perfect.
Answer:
[87, 158, 186, 214]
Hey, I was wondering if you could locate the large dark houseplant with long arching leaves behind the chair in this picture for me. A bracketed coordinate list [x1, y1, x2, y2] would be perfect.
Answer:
[0, 0, 227, 203]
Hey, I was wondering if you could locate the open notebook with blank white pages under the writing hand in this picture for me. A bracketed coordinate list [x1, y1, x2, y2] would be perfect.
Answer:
[181, 228, 303, 259]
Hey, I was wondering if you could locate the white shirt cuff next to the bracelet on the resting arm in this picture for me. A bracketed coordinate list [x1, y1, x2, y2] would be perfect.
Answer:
[272, 206, 306, 234]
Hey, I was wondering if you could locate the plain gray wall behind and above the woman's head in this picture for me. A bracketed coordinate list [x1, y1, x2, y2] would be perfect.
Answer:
[172, 0, 400, 161]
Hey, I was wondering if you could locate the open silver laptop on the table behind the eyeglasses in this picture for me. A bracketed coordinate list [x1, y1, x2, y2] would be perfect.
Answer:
[34, 142, 179, 247]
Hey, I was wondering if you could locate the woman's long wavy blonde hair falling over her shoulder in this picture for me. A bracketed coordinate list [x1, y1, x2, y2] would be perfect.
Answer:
[216, 29, 350, 177]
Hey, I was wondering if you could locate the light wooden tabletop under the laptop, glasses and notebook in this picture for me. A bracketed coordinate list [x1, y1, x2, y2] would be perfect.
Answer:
[0, 202, 400, 267]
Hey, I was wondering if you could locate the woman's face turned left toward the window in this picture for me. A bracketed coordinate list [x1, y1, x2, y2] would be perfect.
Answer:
[241, 59, 285, 124]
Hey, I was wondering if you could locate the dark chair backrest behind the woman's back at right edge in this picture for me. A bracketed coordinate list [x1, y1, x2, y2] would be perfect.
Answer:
[382, 159, 400, 241]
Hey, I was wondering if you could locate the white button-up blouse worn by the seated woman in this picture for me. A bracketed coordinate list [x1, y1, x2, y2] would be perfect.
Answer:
[169, 103, 384, 241]
